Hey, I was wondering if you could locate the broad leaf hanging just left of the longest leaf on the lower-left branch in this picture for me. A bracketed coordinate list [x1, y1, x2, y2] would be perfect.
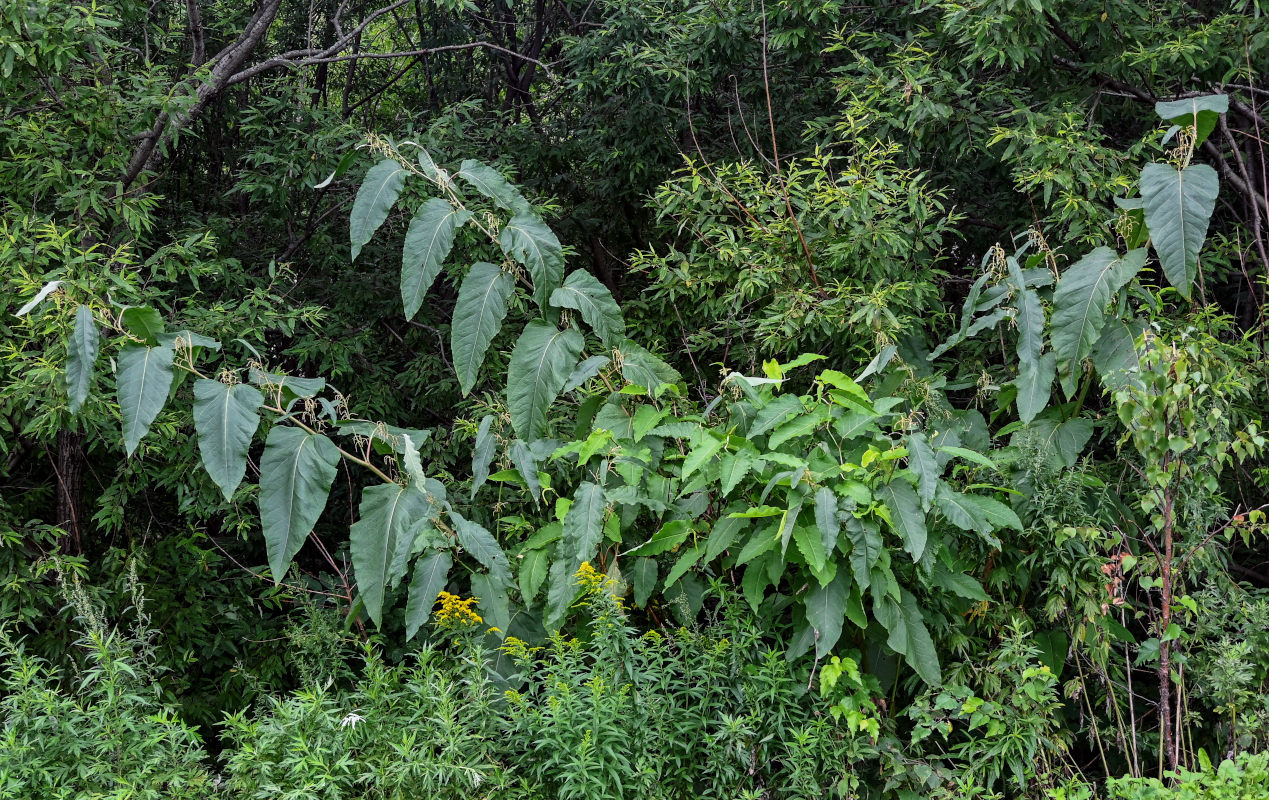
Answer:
[194, 378, 264, 502]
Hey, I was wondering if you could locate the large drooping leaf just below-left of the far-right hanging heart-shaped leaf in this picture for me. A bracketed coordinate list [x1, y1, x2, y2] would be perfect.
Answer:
[1051, 248, 1146, 362]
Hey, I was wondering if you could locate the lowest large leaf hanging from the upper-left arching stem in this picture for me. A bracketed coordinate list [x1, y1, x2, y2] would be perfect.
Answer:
[506, 320, 582, 441]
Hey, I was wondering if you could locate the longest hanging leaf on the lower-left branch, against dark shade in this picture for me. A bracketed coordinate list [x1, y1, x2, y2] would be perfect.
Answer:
[260, 425, 339, 583]
